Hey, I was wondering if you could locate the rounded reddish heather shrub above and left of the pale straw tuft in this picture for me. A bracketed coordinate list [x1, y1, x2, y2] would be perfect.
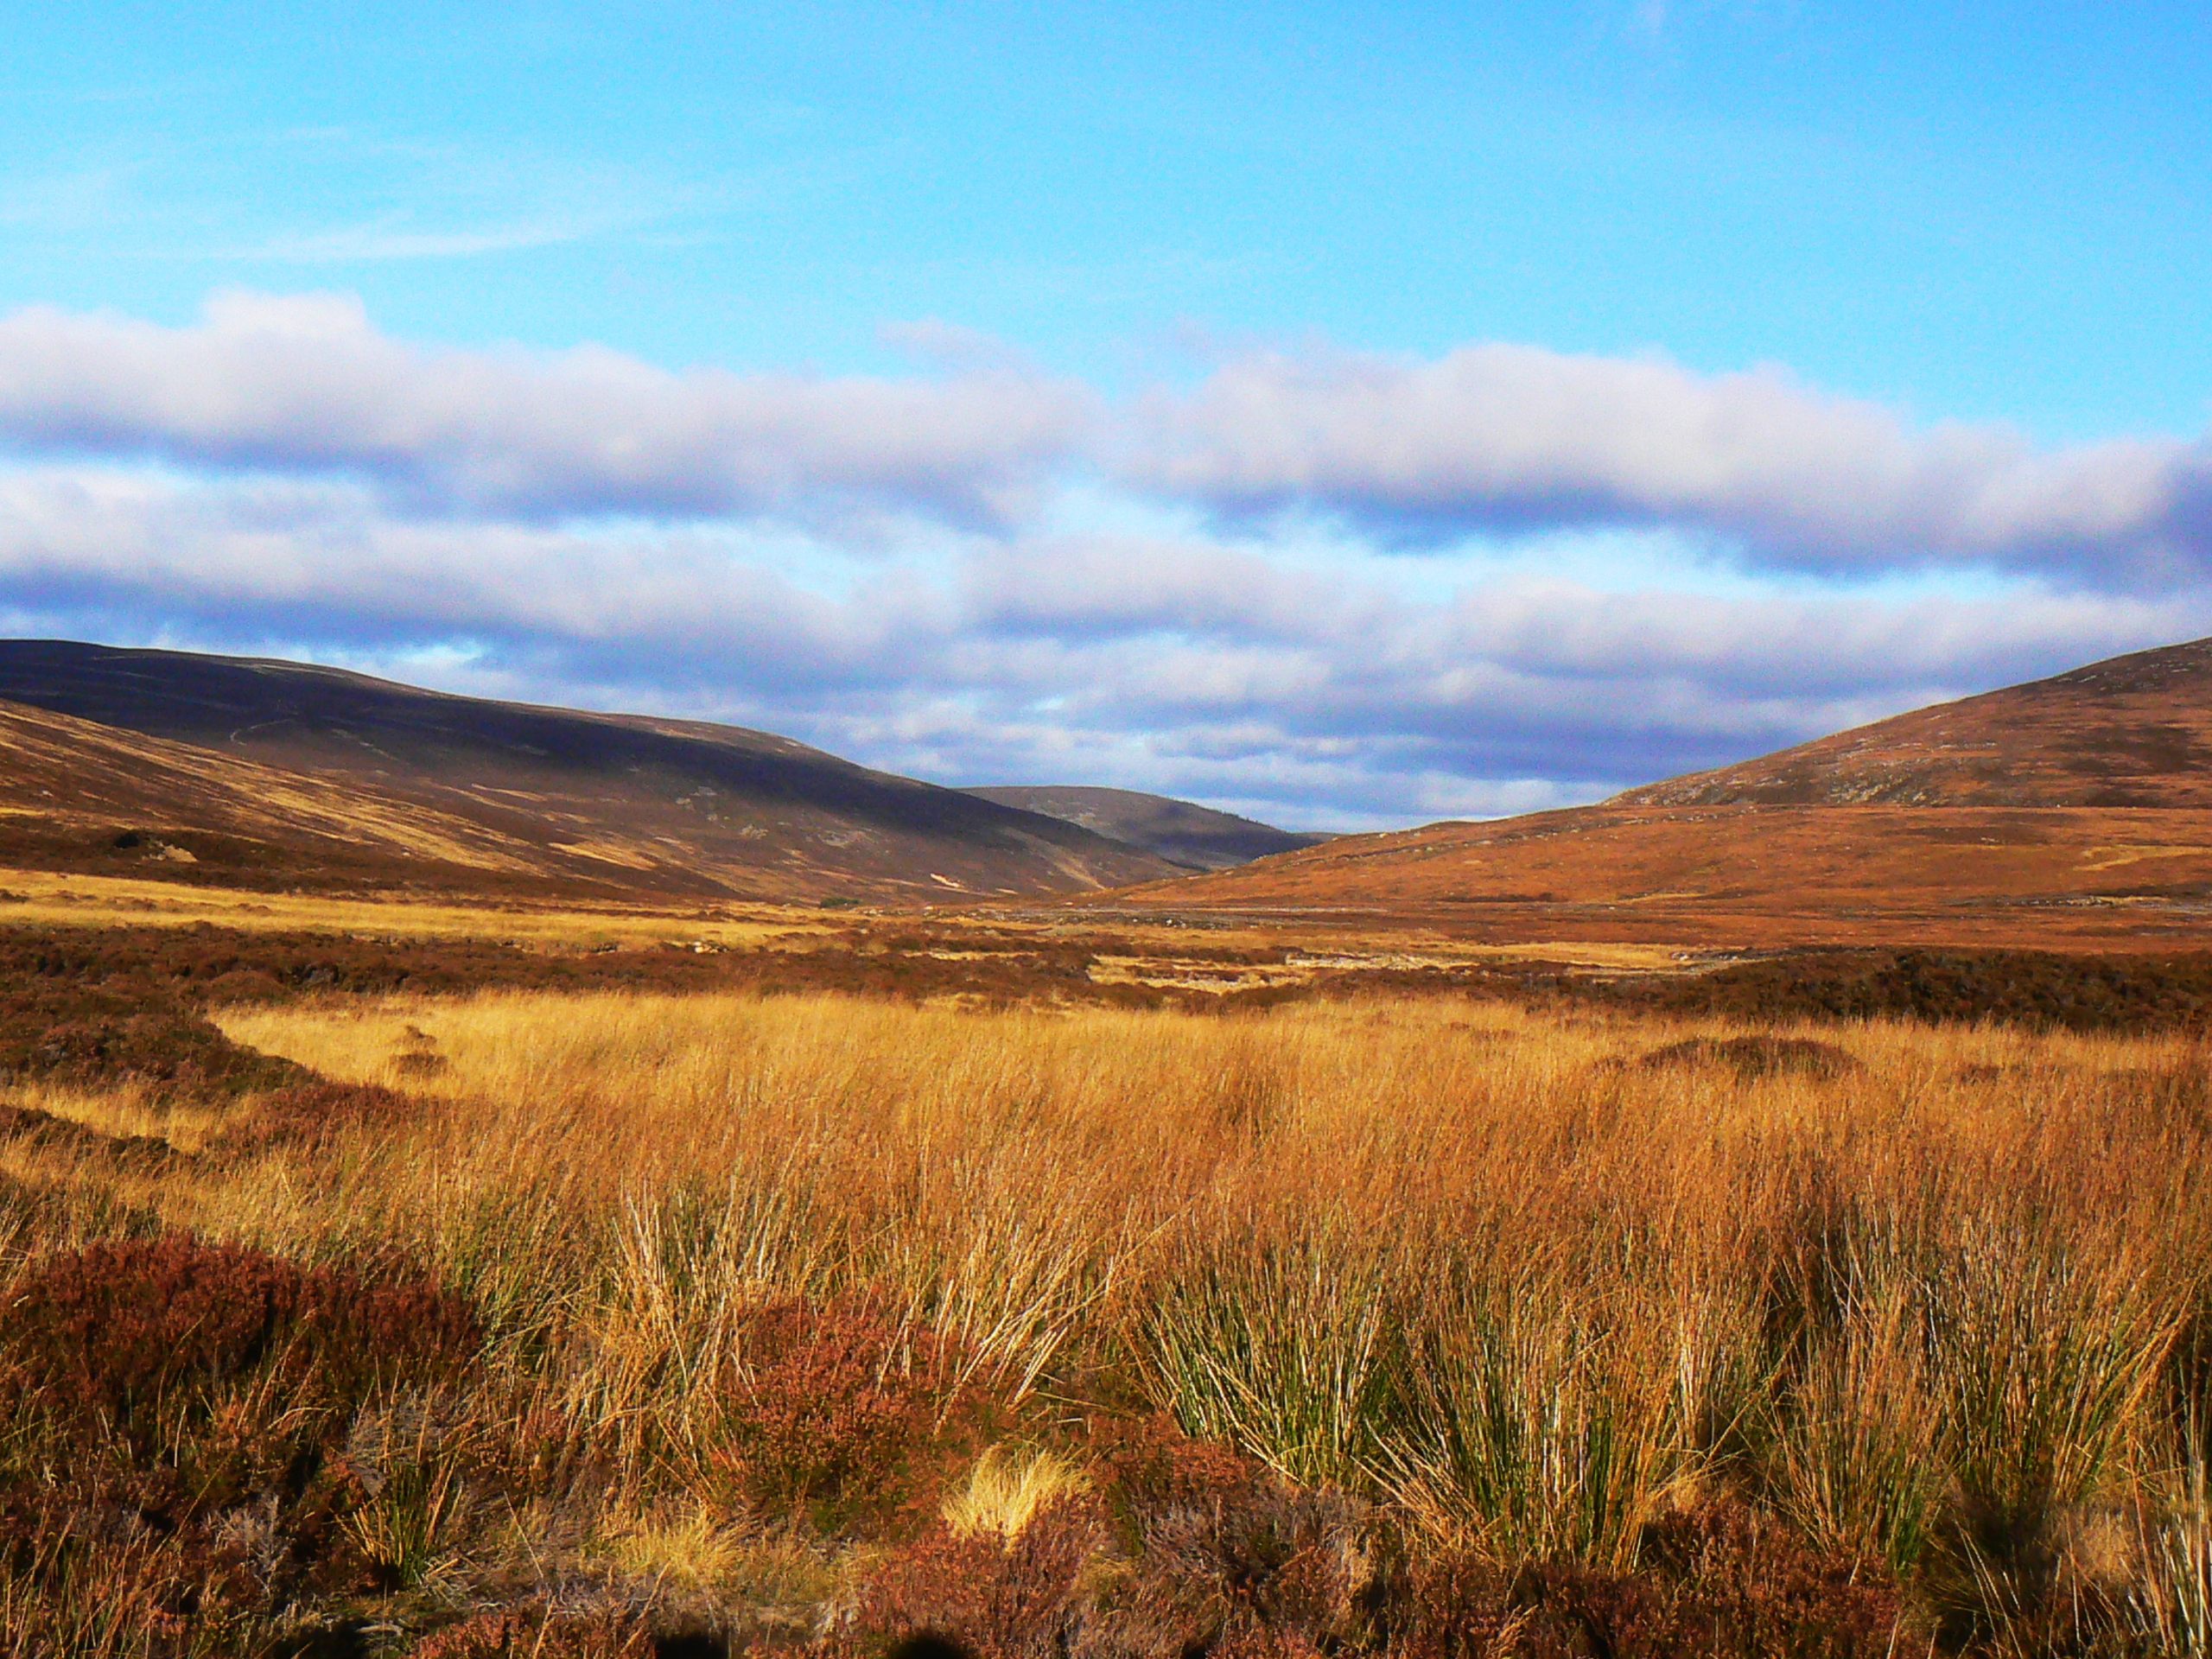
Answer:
[710, 1299, 988, 1531]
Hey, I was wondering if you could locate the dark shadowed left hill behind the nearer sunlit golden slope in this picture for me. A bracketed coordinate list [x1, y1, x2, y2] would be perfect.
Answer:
[0, 639, 1174, 900]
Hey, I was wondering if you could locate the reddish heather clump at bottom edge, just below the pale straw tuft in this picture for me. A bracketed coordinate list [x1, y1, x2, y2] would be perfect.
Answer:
[852, 1500, 1110, 1659]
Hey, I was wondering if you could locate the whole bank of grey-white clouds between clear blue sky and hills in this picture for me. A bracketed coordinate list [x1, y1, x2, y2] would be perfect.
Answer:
[0, 296, 2212, 827]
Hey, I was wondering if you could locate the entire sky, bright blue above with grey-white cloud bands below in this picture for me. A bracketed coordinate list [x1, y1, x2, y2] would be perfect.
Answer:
[0, 0, 2212, 830]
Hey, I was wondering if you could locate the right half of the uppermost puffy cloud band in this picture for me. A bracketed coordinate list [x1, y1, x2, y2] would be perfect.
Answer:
[1123, 345, 2212, 582]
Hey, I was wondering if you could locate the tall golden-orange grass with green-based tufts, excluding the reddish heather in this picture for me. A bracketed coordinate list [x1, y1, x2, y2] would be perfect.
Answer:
[26, 993, 2212, 1650]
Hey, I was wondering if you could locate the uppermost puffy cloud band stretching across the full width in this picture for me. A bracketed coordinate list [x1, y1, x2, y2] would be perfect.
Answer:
[0, 294, 2212, 586]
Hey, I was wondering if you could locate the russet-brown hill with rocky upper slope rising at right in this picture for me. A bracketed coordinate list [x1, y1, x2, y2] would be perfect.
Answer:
[1103, 641, 2212, 944]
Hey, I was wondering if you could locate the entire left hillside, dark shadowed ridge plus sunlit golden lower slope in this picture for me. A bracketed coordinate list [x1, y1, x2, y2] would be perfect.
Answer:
[0, 639, 1174, 900]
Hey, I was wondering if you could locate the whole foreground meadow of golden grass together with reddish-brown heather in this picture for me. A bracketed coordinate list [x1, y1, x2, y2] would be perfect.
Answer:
[13, 955, 2212, 1659]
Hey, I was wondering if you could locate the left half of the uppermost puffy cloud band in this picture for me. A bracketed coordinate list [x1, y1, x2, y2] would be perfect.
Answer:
[0, 294, 1090, 524]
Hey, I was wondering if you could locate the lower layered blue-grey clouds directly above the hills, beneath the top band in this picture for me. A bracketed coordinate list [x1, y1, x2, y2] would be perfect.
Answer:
[0, 465, 2212, 827]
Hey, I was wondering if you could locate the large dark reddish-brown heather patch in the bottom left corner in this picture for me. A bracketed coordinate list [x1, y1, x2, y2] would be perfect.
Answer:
[0, 1234, 482, 1652]
